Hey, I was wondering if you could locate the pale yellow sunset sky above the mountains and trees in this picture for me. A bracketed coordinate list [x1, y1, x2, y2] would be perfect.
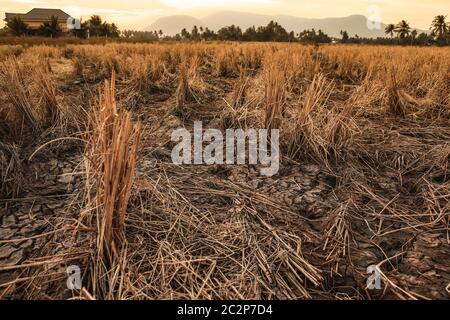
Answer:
[0, 0, 450, 29]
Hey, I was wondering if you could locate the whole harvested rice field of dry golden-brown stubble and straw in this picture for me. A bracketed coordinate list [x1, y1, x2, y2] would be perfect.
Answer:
[0, 43, 450, 299]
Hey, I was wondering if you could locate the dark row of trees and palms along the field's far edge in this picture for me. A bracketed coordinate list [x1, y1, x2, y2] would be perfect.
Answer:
[4, 15, 450, 45]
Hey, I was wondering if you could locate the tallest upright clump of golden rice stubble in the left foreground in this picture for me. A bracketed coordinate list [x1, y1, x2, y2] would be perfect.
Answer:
[86, 72, 141, 297]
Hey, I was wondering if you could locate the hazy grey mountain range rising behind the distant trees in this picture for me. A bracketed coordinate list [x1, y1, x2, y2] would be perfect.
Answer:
[144, 11, 424, 38]
